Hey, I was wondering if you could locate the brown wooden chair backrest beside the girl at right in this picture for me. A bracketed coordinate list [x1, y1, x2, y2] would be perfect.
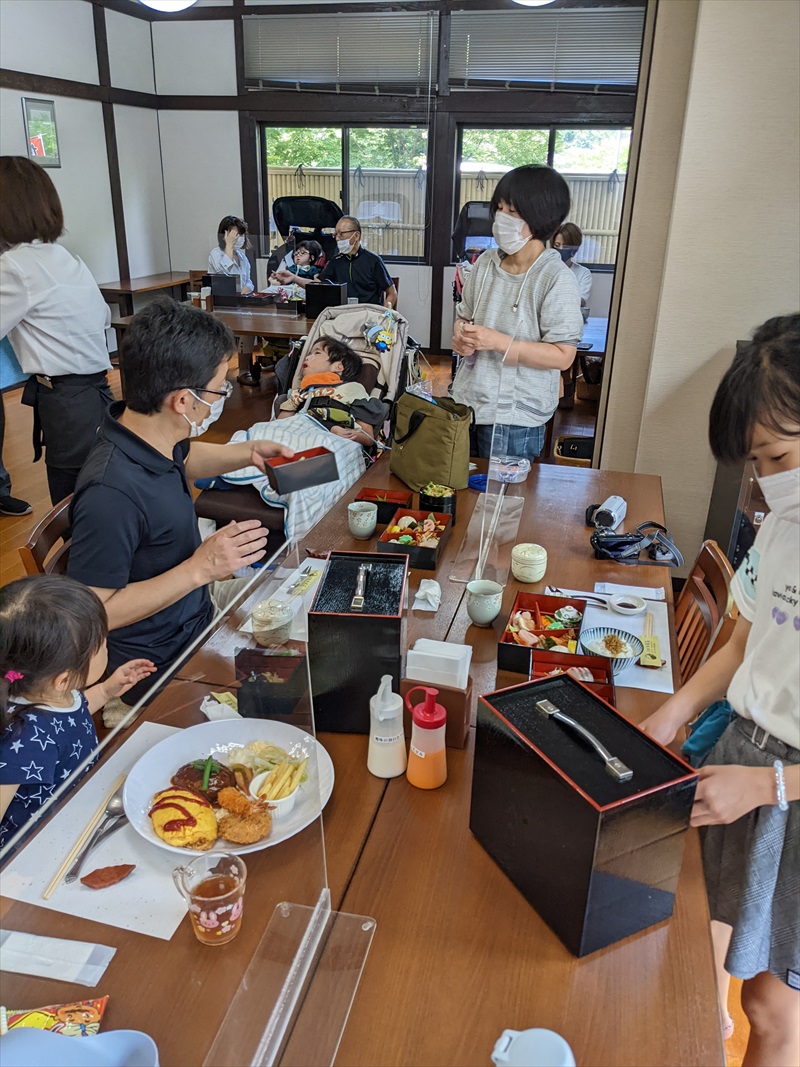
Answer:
[675, 541, 733, 684]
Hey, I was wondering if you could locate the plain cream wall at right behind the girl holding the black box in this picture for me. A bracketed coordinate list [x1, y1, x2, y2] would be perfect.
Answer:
[636, 0, 800, 576]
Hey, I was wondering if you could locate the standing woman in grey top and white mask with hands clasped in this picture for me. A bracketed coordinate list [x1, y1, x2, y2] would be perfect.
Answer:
[452, 166, 583, 460]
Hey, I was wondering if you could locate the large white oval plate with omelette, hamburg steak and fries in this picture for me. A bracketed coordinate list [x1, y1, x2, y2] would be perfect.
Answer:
[123, 719, 334, 856]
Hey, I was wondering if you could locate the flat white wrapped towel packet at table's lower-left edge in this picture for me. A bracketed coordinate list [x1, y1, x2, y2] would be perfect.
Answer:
[0, 930, 116, 986]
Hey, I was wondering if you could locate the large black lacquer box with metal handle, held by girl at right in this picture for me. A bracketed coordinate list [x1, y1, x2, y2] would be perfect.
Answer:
[469, 675, 697, 956]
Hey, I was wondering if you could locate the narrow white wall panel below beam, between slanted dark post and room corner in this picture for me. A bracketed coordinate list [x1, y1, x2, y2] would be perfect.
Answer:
[114, 105, 170, 277]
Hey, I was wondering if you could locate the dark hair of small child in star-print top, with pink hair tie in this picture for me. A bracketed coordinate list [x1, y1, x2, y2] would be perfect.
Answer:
[0, 574, 108, 733]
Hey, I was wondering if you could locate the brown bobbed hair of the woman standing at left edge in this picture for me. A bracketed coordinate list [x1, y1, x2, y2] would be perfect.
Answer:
[0, 156, 64, 252]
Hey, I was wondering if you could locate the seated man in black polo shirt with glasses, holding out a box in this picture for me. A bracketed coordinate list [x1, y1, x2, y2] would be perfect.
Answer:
[68, 297, 293, 712]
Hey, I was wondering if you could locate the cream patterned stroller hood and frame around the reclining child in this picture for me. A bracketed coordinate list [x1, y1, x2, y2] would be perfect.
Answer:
[273, 304, 421, 448]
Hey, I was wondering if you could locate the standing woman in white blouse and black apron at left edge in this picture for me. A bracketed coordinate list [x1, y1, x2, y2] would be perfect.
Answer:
[0, 156, 113, 504]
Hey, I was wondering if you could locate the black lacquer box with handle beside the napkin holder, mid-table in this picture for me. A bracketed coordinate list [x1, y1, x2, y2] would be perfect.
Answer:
[308, 552, 409, 733]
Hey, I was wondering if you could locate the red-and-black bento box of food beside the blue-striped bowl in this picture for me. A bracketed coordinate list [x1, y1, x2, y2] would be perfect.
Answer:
[497, 592, 586, 675]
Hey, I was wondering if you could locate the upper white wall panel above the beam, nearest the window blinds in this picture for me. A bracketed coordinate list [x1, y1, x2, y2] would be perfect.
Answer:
[151, 18, 236, 96]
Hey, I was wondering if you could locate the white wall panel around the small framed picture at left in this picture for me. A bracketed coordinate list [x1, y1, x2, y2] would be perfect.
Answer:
[0, 89, 119, 282]
